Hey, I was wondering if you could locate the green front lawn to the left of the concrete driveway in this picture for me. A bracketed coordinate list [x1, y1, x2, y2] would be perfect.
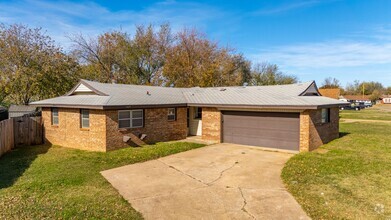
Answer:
[0, 142, 207, 219]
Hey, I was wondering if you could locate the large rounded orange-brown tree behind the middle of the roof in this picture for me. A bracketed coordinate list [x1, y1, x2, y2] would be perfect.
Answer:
[163, 29, 250, 87]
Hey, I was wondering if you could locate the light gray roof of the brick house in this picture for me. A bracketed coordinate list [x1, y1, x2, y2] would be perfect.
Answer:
[31, 80, 345, 108]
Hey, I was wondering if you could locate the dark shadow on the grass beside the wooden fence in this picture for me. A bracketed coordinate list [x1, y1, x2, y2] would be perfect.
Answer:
[0, 145, 51, 189]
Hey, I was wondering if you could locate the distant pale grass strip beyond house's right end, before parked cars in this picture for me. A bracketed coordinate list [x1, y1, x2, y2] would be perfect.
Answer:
[340, 105, 391, 121]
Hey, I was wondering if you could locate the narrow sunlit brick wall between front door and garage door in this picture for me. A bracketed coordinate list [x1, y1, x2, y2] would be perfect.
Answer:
[202, 108, 221, 143]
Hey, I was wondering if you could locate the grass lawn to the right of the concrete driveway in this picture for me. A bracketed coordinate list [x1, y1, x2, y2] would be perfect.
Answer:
[281, 121, 391, 219]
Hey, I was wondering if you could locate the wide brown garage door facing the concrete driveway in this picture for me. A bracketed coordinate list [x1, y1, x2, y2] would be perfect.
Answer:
[223, 111, 300, 151]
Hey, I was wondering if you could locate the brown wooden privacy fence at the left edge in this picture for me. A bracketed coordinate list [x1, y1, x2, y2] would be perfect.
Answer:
[0, 115, 43, 156]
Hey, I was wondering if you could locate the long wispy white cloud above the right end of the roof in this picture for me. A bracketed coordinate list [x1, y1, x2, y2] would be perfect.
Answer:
[251, 41, 391, 68]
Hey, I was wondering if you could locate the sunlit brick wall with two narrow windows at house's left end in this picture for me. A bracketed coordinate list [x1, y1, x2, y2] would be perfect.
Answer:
[42, 108, 106, 151]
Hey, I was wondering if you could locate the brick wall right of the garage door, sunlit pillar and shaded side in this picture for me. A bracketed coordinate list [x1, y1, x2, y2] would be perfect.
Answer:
[300, 108, 339, 151]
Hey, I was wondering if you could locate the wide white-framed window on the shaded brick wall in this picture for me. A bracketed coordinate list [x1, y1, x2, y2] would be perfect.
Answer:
[118, 109, 144, 128]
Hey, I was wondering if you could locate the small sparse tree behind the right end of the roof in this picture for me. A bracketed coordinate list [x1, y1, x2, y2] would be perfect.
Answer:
[251, 62, 297, 86]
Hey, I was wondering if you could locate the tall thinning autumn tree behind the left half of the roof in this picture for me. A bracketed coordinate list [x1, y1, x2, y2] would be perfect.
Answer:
[70, 24, 173, 85]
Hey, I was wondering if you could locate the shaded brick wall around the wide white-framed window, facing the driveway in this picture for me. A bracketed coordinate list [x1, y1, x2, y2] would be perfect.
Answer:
[106, 107, 187, 150]
